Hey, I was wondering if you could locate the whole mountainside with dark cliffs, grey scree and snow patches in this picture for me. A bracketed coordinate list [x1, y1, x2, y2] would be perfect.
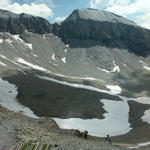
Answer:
[0, 9, 150, 142]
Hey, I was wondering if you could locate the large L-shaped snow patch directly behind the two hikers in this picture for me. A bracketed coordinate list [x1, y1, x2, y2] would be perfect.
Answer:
[53, 99, 131, 137]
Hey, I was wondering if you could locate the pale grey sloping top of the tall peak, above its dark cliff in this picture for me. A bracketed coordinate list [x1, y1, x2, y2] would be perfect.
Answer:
[65, 8, 136, 25]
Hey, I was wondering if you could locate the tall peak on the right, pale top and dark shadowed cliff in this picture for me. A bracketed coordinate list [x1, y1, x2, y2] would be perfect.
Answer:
[59, 9, 150, 56]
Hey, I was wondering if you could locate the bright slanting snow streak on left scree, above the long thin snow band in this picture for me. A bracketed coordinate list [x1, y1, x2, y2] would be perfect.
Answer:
[16, 58, 47, 71]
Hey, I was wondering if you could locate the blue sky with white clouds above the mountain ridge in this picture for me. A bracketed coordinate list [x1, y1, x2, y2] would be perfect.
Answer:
[0, 0, 150, 29]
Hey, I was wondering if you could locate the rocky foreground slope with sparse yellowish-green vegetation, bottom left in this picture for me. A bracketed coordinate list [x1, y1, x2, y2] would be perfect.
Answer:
[0, 107, 131, 150]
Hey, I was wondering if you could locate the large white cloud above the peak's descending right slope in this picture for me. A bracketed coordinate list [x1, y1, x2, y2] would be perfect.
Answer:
[90, 0, 150, 29]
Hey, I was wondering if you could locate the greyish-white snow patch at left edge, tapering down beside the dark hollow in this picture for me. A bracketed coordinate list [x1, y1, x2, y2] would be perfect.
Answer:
[0, 78, 38, 118]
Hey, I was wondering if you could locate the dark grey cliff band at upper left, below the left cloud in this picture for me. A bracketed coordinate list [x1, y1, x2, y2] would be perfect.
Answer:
[0, 10, 52, 34]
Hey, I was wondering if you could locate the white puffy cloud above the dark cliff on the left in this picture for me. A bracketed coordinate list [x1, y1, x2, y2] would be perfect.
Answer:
[0, 0, 53, 18]
